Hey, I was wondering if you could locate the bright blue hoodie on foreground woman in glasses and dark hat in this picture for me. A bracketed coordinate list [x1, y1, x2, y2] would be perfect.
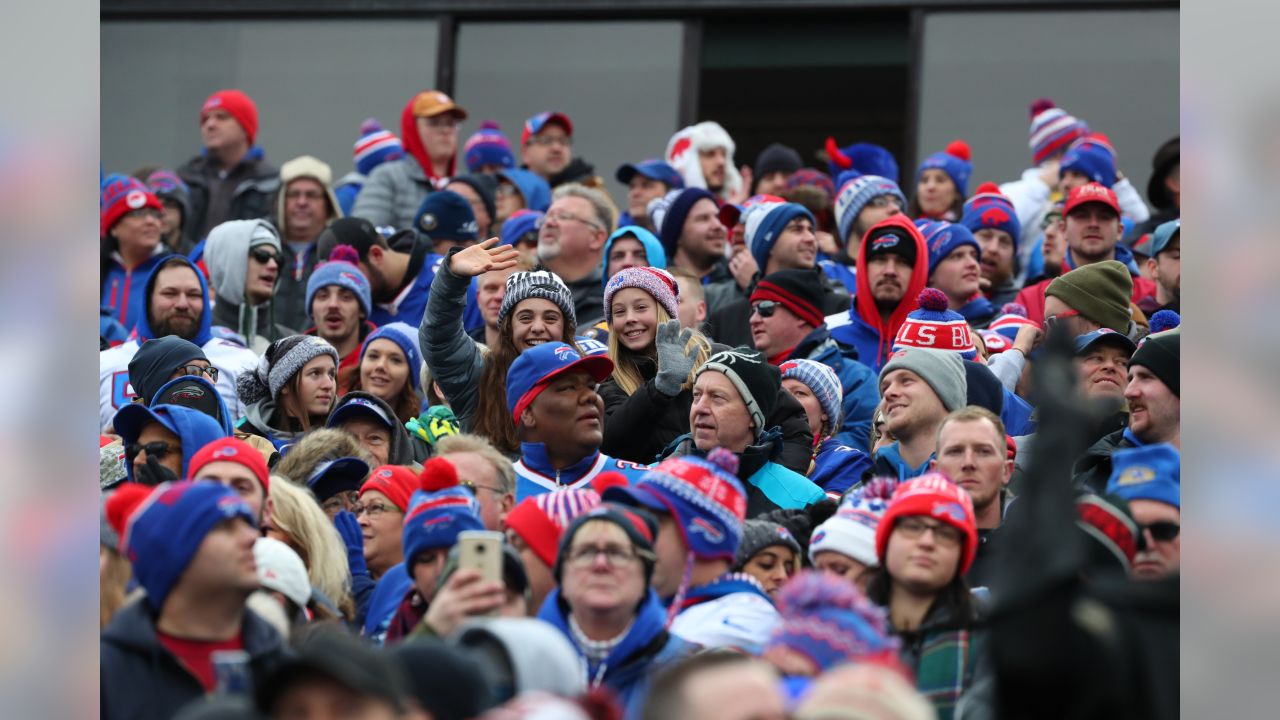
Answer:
[538, 588, 694, 720]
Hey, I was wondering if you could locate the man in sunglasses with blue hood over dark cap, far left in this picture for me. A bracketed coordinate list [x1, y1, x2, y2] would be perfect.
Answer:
[111, 404, 228, 486]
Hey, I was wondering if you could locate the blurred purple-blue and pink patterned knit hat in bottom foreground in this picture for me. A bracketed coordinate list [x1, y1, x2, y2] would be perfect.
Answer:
[767, 570, 900, 673]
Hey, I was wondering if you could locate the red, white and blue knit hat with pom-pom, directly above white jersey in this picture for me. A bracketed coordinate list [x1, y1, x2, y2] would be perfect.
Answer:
[604, 447, 746, 562]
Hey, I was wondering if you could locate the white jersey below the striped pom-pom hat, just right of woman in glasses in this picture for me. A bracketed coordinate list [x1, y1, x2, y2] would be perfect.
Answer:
[671, 592, 782, 655]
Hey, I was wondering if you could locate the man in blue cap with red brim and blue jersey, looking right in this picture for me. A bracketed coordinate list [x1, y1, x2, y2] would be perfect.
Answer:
[507, 342, 645, 502]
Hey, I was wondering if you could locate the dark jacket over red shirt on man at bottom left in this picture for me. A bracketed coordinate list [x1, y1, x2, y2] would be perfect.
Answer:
[99, 600, 288, 720]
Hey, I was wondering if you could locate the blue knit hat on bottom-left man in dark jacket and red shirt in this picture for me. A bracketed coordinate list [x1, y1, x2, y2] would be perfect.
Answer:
[120, 482, 257, 612]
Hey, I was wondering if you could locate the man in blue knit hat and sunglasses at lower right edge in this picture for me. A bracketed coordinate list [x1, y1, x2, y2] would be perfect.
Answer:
[1107, 443, 1183, 580]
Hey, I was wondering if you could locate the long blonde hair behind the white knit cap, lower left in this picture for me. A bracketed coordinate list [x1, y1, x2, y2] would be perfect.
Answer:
[269, 475, 356, 620]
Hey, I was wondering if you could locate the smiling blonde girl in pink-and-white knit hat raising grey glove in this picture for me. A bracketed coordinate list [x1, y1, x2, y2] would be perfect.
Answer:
[599, 268, 710, 462]
